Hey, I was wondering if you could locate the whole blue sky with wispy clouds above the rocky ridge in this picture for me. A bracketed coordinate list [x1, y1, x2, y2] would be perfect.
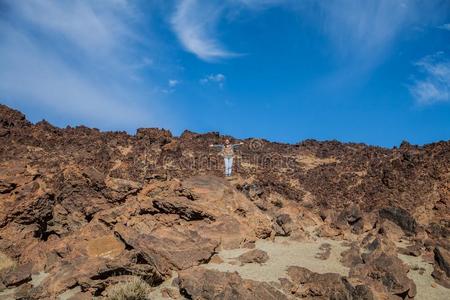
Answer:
[0, 0, 450, 147]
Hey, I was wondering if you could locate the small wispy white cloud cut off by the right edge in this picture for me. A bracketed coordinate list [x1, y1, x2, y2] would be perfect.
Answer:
[409, 52, 450, 105]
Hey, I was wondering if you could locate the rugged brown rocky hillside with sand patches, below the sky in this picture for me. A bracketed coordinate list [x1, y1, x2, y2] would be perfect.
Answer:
[0, 105, 450, 299]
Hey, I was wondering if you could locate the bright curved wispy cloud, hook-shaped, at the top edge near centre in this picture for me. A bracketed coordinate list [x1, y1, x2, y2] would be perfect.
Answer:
[171, 0, 237, 62]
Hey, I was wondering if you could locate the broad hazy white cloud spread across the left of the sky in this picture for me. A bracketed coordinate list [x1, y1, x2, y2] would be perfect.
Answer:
[0, 0, 164, 128]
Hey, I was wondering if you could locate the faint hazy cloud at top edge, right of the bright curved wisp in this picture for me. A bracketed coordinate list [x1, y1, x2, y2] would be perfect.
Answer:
[309, 0, 417, 65]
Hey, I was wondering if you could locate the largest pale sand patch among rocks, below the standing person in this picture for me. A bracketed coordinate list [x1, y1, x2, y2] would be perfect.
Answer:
[204, 237, 349, 282]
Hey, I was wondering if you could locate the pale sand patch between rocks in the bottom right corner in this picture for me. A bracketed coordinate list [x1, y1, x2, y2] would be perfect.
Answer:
[398, 254, 450, 300]
